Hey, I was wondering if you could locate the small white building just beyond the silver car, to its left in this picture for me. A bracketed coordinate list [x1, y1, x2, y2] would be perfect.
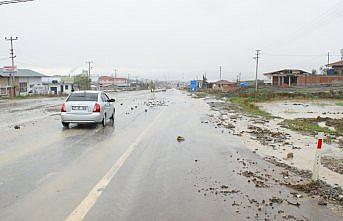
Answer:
[42, 76, 74, 95]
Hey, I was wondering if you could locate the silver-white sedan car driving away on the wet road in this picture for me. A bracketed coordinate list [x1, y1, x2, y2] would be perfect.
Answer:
[61, 91, 115, 127]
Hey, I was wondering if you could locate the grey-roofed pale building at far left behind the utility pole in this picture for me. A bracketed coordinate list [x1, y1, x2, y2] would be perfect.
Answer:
[0, 68, 46, 96]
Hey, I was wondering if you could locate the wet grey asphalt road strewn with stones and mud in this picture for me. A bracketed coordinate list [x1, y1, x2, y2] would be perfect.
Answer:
[0, 90, 342, 220]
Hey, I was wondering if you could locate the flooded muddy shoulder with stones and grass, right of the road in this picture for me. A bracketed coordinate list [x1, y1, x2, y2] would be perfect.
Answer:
[196, 89, 343, 207]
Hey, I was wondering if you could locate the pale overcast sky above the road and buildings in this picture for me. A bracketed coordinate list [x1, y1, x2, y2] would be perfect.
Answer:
[0, 0, 343, 80]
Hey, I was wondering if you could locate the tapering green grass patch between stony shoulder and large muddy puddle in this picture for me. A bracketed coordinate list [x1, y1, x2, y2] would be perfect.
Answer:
[229, 97, 273, 119]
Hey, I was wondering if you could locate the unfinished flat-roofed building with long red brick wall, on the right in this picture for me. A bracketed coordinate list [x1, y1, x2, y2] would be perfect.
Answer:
[264, 69, 343, 87]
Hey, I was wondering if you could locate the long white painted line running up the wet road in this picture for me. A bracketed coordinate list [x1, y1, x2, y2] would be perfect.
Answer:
[65, 111, 163, 221]
